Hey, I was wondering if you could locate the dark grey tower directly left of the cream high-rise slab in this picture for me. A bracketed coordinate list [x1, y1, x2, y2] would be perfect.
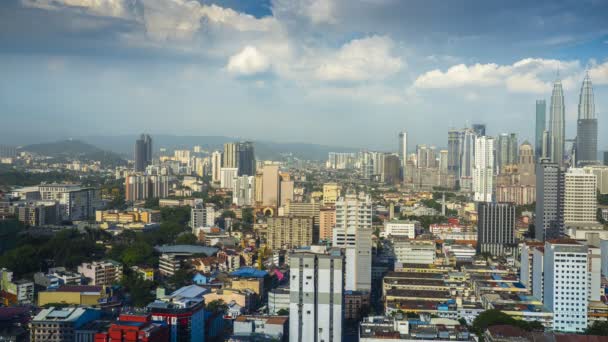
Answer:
[534, 160, 564, 241]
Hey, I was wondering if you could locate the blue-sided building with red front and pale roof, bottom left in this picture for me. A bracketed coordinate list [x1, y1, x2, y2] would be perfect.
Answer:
[147, 285, 209, 342]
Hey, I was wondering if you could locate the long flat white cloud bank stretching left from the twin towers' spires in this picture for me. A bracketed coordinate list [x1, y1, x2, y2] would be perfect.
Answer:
[414, 58, 580, 93]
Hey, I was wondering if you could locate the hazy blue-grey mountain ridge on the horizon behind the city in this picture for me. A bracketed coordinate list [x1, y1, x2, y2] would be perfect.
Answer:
[19, 135, 358, 165]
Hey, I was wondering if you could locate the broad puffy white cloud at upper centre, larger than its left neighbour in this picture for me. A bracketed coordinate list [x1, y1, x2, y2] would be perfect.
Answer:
[315, 36, 404, 81]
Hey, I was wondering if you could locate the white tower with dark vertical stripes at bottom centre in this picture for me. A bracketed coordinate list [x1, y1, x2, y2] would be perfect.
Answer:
[289, 246, 345, 342]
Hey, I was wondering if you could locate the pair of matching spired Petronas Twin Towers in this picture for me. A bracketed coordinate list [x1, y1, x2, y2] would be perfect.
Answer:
[549, 73, 597, 166]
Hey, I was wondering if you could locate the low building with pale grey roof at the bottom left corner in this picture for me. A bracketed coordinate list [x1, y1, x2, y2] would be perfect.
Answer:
[30, 307, 101, 342]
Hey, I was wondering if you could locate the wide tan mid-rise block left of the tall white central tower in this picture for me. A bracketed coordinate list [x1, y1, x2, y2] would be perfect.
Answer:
[266, 216, 313, 250]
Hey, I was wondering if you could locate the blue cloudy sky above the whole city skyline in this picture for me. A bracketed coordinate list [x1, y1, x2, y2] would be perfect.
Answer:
[0, 0, 608, 150]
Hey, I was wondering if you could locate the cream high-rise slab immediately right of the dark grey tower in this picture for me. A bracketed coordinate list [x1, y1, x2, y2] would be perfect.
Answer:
[564, 168, 597, 224]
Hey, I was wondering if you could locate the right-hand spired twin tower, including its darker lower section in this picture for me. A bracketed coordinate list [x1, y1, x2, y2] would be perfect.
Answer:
[576, 73, 597, 165]
